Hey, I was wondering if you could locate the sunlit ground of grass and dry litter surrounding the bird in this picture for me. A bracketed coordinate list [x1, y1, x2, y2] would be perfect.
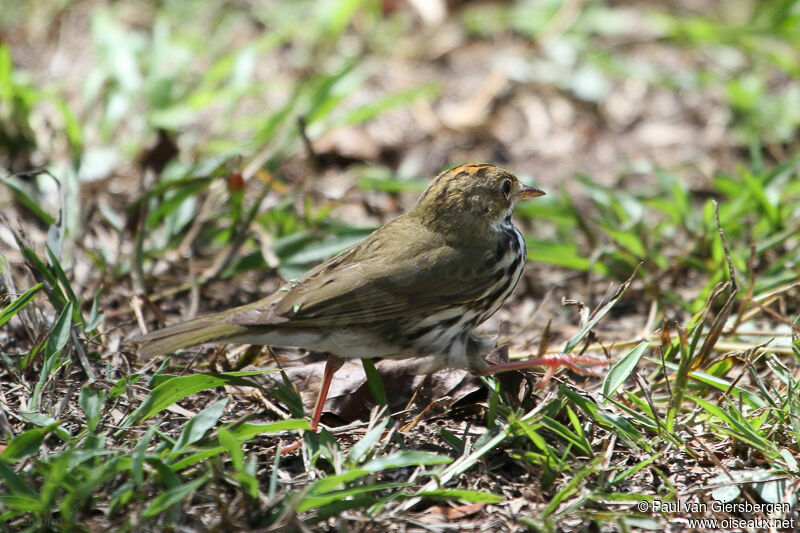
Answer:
[0, 0, 800, 531]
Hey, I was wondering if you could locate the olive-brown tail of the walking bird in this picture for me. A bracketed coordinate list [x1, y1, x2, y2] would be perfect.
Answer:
[131, 312, 247, 359]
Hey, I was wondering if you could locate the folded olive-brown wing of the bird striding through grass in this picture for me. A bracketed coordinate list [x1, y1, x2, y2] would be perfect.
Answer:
[226, 218, 504, 326]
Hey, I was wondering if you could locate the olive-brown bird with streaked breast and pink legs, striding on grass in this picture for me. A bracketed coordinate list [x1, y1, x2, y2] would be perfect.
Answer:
[133, 163, 605, 431]
